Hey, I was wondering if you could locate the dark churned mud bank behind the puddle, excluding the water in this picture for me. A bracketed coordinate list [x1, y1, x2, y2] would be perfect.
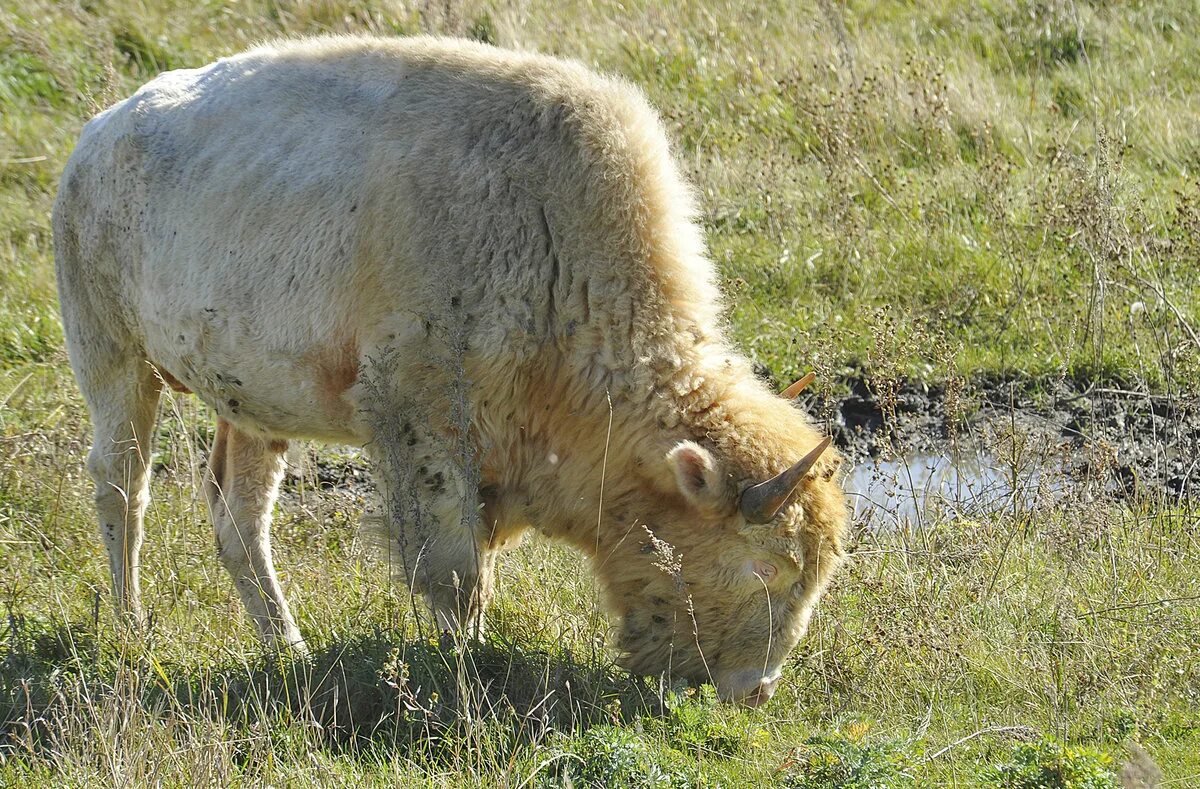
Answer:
[802, 379, 1200, 499]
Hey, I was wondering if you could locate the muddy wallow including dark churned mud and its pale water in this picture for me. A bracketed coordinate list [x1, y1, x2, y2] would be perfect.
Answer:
[802, 379, 1200, 529]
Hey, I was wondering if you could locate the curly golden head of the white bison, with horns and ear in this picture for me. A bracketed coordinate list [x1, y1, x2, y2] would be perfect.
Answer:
[599, 374, 847, 706]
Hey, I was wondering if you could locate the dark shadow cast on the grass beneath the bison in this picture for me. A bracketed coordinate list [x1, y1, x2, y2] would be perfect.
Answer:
[0, 618, 664, 760]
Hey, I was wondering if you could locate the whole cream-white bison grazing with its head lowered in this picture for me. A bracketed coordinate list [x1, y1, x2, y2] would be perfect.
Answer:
[54, 37, 847, 704]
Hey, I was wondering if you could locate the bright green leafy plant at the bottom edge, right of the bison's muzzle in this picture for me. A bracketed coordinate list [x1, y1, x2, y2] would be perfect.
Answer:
[984, 737, 1120, 789]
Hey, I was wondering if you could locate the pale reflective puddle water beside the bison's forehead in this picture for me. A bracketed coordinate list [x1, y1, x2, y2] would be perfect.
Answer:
[846, 453, 1072, 529]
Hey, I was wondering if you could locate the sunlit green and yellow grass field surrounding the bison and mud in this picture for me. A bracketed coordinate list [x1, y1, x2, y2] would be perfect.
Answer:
[0, 0, 1200, 789]
